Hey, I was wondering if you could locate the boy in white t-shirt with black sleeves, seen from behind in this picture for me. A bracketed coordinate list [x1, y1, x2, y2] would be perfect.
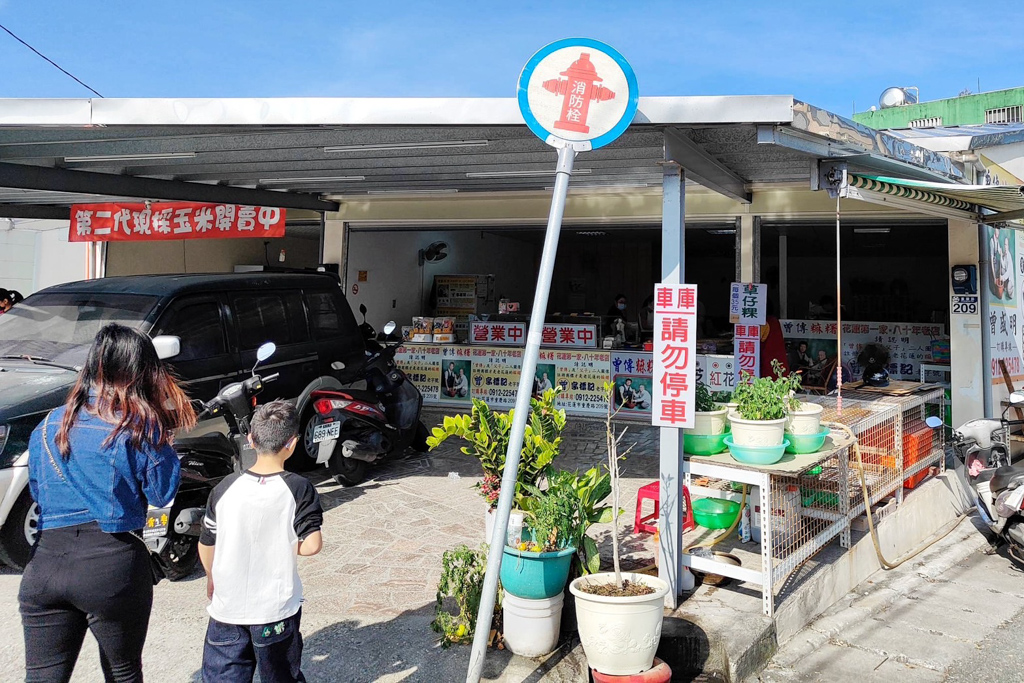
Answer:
[199, 400, 324, 683]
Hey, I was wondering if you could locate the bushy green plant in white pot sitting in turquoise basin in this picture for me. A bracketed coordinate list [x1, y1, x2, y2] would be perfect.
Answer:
[729, 361, 791, 446]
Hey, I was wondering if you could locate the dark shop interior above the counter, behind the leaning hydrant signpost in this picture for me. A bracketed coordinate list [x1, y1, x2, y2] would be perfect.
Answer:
[346, 222, 736, 344]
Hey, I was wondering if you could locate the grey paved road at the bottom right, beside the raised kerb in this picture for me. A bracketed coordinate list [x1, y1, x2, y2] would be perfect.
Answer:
[759, 520, 1024, 683]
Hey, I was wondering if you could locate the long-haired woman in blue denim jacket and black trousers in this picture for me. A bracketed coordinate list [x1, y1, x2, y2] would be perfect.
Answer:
[18, 325, 196, 682]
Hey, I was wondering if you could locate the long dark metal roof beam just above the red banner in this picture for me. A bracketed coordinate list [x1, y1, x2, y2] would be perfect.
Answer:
[0, 163, 339, 211]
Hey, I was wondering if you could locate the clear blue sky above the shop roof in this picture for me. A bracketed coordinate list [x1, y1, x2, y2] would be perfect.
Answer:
[0, 0, 1024, 116]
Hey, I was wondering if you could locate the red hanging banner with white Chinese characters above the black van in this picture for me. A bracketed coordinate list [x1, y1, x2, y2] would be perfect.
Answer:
[69, 202, 285, 242]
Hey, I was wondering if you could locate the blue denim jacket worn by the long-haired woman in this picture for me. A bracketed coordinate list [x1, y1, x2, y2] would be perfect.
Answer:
[29, 407, 181, 533]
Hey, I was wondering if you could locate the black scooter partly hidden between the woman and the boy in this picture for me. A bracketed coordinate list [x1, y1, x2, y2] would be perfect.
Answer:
[142, 342, 278, 581]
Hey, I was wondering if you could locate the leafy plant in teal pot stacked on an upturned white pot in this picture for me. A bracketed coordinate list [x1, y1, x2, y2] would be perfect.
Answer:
[501, 485, 580, 657]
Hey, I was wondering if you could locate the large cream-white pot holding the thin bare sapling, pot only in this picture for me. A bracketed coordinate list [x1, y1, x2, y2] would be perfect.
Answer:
[569, 572, 669, 676]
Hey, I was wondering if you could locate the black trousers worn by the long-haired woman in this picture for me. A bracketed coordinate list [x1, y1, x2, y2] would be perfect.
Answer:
[17, 522, 153, 683]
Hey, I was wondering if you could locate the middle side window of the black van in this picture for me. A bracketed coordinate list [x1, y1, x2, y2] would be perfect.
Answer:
[232, 292, 309, 351]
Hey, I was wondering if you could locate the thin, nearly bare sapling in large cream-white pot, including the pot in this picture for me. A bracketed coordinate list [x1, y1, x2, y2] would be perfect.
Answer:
[569, 383, 669, 676]
